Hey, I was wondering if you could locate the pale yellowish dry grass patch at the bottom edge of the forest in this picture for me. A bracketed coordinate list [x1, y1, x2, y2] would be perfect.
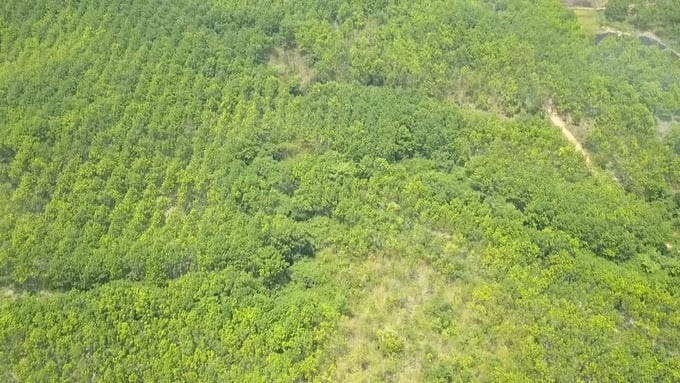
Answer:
[335, 257, 472, 382]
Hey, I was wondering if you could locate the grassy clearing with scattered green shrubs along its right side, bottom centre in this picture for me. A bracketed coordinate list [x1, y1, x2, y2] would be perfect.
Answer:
[330, 226, 488, 383]
